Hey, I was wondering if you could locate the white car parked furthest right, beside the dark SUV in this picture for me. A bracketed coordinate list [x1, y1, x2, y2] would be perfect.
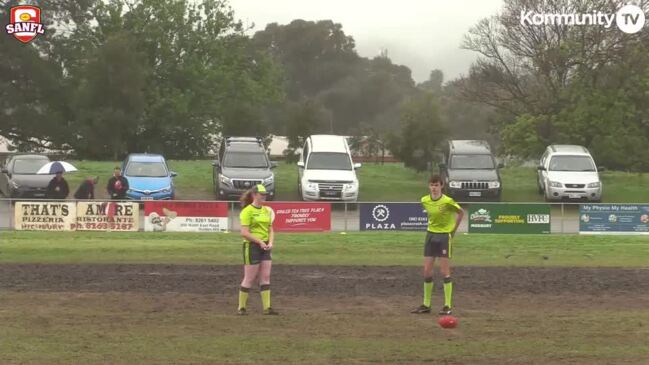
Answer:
[537, 145, 602, 202]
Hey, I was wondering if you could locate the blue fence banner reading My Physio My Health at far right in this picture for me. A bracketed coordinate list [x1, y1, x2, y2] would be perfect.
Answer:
[579, 204, 649, 234]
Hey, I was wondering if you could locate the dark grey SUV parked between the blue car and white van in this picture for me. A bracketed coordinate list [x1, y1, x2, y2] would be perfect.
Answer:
[212, 137, 277, 200]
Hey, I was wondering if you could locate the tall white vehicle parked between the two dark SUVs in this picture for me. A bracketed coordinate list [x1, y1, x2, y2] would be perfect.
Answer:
[297, 135, 361, 201]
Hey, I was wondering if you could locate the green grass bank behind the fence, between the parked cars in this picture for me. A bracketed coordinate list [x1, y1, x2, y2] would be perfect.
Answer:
[58, 160, 649, 203]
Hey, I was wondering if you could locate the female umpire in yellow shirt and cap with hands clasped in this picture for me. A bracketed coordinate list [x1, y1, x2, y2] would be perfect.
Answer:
[238, 184, 278, 315]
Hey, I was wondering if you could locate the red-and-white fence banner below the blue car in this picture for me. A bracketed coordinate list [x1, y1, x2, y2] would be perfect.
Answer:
[144, 200, 228, 232]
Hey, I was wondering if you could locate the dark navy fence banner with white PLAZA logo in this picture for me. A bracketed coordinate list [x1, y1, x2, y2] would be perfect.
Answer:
[359, 203, 428, 231]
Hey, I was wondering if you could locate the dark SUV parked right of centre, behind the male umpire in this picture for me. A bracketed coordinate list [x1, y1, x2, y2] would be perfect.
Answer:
[439, 140, 503, 201]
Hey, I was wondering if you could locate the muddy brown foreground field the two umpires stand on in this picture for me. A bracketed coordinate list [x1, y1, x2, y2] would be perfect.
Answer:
[0, 264, 649, 365]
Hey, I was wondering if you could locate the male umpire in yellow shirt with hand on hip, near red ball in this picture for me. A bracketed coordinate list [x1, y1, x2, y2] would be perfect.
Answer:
[412, 176, 464, 315]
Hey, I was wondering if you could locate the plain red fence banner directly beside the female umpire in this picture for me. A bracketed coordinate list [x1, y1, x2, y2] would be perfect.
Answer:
[266, 202, 331, 232]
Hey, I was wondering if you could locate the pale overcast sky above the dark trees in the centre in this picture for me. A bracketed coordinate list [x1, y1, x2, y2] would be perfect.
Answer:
[230, 0, 502, 82]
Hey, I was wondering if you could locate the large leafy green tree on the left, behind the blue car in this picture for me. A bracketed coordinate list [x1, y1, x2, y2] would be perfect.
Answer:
[0, 0, 282, 158]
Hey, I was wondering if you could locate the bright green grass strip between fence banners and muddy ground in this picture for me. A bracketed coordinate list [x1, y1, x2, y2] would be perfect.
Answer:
[0, 232, 649, 267]
